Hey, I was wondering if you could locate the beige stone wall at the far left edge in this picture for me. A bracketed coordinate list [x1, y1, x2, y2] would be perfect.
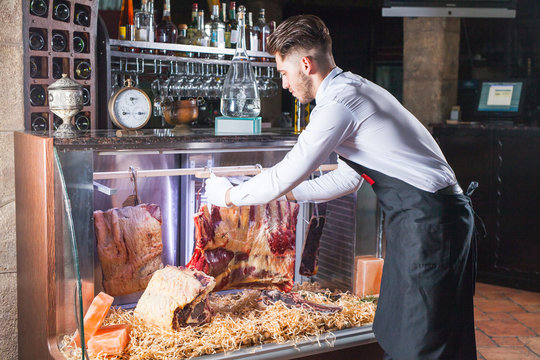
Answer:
[0, 0, 24, 360]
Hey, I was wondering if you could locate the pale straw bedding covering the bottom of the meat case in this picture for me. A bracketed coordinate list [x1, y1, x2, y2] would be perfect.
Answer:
[62, 283, 377, 360]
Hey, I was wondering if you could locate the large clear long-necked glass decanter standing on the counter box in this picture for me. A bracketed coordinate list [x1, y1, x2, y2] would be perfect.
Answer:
[221, 6, 261, 118]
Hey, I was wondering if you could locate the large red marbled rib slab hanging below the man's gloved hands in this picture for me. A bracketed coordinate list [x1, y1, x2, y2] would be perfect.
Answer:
[187, 201, 299, 291]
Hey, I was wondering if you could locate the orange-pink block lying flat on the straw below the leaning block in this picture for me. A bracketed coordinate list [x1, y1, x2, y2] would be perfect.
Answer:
[88, 324, 131, 356]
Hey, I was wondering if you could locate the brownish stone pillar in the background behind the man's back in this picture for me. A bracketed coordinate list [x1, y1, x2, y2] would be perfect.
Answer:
[403, 18, 460, 125]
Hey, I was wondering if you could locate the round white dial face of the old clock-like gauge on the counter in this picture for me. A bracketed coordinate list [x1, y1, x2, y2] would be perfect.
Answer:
[113, 88, 152, 129]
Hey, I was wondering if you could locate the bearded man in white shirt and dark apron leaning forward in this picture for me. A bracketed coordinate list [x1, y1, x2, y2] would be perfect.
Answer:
[206, 15, 476, 360]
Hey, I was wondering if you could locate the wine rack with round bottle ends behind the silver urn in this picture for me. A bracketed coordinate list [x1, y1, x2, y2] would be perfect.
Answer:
[23, 0, 98, 132]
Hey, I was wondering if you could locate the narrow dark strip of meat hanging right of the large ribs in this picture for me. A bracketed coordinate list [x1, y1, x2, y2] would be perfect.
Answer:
[299, 203, 326, 276]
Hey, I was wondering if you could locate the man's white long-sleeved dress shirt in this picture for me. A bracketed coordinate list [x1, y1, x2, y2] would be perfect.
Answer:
[230, 67, 457, 206]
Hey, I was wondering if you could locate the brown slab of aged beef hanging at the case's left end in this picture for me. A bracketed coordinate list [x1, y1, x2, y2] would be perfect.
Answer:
[94, 204, 163, 296]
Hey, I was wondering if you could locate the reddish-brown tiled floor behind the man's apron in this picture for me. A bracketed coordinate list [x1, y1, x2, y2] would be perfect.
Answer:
[474, 283, 540, 360]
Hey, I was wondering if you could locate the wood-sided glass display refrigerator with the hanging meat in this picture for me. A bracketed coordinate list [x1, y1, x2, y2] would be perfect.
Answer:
[15, 129, 384, 359]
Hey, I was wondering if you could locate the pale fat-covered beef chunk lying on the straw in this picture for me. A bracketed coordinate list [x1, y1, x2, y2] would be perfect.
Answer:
[134, 265, 216, 330]
